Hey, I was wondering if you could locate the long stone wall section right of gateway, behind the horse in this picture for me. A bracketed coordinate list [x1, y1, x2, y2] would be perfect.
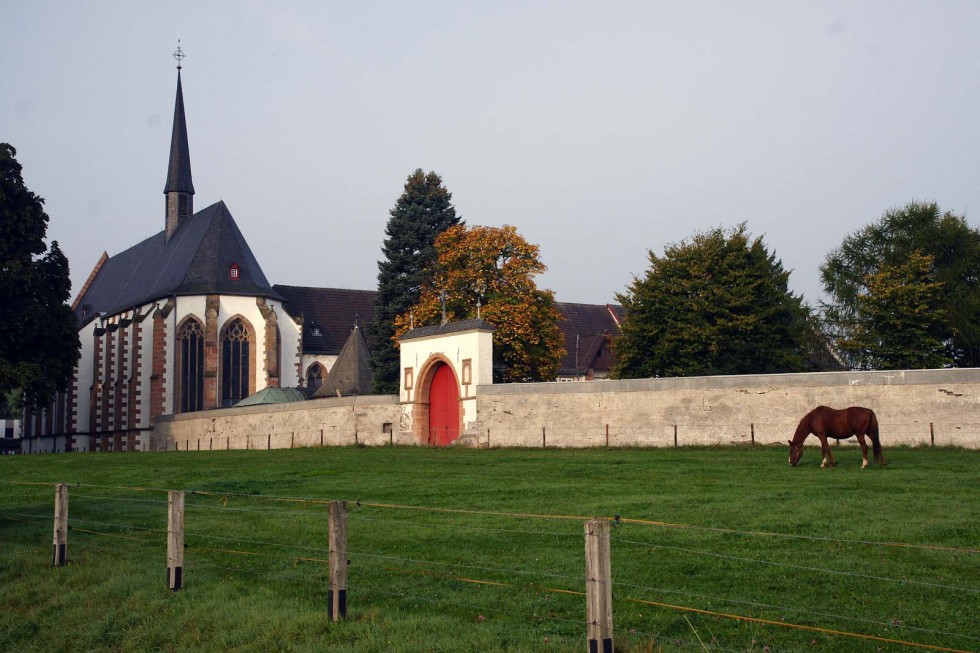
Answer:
[465, 368, 980, 449]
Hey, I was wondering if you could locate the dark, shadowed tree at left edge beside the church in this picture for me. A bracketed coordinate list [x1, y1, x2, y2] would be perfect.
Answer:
[0, 143, 80, 408]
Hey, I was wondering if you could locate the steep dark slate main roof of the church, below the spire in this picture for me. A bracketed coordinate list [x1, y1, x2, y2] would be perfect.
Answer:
[75, 197, 282, 324]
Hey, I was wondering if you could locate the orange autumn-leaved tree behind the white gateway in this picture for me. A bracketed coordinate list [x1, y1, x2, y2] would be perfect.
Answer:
[395, 225, 565, 382]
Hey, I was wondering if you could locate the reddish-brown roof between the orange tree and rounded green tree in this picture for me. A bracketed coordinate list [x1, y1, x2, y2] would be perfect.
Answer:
[556, 302, 625, 375]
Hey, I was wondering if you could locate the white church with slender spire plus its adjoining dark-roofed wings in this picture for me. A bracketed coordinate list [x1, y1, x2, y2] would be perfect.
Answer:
[21, 65, 622, 451]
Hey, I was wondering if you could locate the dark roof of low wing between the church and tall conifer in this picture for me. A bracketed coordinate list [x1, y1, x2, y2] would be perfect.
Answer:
[273, 285, 377, 355]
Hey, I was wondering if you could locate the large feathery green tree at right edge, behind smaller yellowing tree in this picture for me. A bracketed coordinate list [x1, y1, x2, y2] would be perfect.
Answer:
[820, 202, 980, 367]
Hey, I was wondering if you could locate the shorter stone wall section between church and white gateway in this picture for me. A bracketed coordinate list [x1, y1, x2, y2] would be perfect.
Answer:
[151, 395, 402, 451]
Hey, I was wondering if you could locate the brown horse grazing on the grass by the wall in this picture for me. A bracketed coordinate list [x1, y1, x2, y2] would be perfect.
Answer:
[789, 406, 887, 469]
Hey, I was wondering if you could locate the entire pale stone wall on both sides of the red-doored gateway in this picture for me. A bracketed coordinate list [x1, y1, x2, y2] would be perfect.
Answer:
[150, 369, 980, 451]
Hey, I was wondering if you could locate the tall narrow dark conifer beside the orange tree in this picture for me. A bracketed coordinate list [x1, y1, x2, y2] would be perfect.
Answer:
[369, 168, 462, 394]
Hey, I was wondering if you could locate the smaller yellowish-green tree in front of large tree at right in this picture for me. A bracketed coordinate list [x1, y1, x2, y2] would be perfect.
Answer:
[840, 251, 953, 370]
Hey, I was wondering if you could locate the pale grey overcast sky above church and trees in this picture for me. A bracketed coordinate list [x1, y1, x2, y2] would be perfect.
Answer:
[0, 0, 980, 305]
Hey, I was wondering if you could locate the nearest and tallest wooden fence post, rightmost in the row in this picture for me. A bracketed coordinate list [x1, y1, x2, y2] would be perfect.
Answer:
[585, 519, 613, 653]
